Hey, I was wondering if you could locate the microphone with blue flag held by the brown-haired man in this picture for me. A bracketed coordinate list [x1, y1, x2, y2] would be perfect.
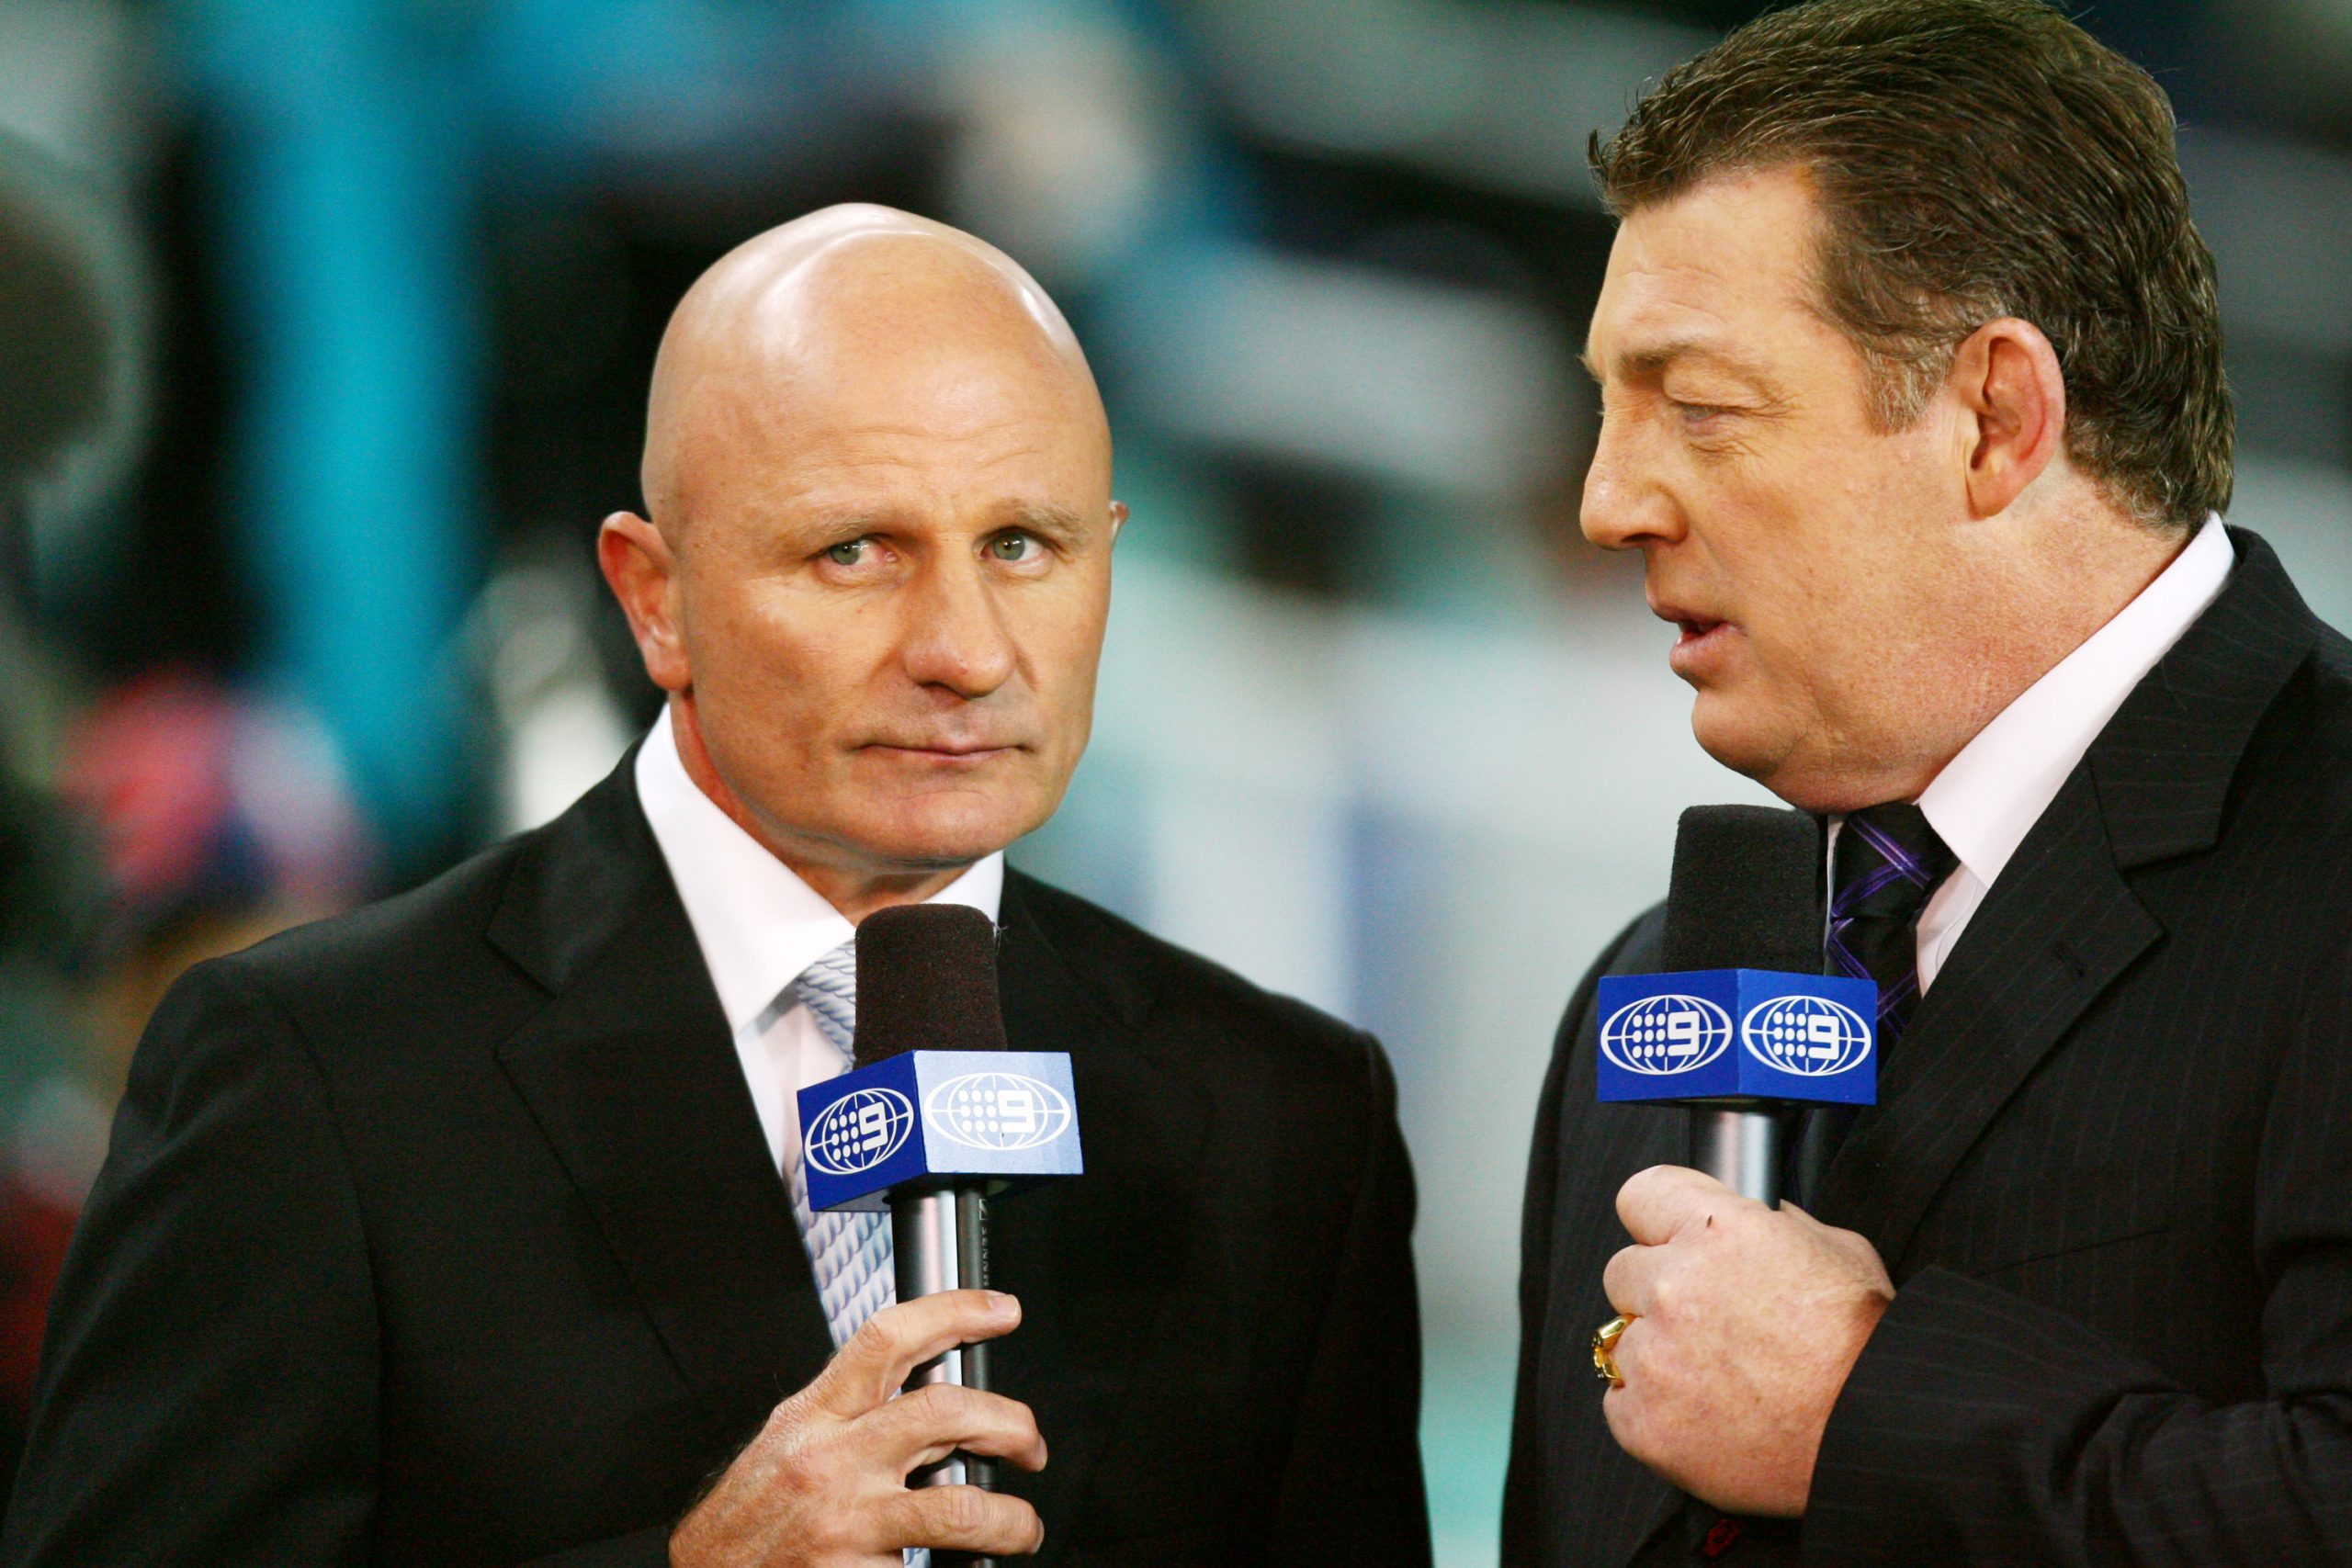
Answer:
[1597, 807, 1879, 1203]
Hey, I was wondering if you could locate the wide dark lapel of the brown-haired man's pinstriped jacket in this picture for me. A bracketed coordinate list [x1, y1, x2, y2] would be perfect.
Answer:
[1820, 529, 2317, 1281]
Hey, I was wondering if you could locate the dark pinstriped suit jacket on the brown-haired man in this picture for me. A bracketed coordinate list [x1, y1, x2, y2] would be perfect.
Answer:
[1505, 534, 2352, 1568]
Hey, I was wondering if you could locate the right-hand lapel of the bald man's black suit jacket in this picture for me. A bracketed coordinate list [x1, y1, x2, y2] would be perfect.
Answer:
[990, 874, 1211, 1542]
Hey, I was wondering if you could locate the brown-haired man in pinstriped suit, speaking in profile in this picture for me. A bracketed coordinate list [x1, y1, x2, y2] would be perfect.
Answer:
[1503, 0, 2352, 1568]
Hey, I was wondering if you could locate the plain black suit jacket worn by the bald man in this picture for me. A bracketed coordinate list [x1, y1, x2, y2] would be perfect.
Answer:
[0, 764, 1430, 1568]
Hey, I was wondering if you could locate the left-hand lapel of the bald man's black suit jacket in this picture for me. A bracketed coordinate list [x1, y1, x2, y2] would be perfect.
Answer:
[489, 752, 832, 1392]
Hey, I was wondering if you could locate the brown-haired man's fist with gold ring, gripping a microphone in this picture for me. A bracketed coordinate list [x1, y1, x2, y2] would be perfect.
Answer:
[1601, 1166, 1895, 1518]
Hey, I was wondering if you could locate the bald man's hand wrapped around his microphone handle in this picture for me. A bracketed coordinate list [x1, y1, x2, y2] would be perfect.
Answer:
[671, 1291, 1045, 1568]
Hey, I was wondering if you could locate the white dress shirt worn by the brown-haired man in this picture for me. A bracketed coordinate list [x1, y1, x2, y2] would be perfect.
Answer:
[1830, 517, 2237, 995]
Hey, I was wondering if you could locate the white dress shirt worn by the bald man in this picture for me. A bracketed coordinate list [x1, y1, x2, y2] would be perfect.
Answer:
[638, 710, 1004, 1173]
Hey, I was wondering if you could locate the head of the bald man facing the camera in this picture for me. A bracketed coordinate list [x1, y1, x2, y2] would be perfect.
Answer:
[597, 207, 1125, 912]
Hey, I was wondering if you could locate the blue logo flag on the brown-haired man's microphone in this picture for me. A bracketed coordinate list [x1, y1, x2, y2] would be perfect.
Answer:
[1597, 968, 1879, 1105]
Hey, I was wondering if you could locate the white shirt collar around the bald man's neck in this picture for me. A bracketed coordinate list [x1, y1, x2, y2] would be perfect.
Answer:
[638, 710, 1004, 1030]
